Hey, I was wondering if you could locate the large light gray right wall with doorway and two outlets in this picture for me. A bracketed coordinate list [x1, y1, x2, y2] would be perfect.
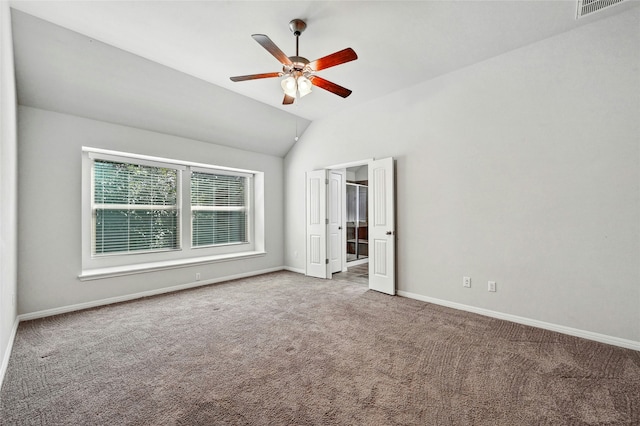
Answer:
[285, 8, 640, 342]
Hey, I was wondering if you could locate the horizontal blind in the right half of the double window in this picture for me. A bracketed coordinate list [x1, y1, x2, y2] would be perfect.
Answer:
[191, 171, 248, 247]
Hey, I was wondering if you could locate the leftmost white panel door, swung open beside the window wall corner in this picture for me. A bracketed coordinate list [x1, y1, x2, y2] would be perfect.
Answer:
[306, 170, 331, 278]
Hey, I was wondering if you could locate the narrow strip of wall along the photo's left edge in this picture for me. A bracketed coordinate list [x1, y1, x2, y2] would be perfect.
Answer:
[0, 2, 18, 385]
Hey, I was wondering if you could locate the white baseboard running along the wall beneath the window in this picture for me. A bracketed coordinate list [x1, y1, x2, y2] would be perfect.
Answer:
[18, 266, 284, 321]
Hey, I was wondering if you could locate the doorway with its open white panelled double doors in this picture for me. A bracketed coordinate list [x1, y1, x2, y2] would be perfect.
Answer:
[305, 157, 396, 295]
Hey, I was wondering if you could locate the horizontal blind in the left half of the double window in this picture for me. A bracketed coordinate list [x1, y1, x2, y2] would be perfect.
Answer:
[92, 160, 180, 255]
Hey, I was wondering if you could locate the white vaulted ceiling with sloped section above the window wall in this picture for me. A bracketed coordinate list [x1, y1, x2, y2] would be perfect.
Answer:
[11, 0, 639, 156]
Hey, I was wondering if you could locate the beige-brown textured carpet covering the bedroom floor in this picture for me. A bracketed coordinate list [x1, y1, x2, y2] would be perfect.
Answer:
[0, 272, 640, 425]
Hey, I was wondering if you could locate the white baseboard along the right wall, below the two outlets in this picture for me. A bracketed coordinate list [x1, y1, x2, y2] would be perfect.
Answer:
[398, 291, 640, 351]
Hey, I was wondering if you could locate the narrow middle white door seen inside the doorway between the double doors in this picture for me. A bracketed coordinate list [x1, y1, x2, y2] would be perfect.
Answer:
[328, 170, 346, 274]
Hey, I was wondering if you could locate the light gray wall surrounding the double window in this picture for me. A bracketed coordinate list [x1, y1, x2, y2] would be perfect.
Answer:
[18, 106, 284, 314]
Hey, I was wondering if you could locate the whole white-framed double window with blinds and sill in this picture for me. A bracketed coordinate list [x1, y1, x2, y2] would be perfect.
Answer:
[80, 148, 265, 279]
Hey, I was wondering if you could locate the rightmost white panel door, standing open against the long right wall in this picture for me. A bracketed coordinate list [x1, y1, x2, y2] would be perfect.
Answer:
[368, 158, 396, 295]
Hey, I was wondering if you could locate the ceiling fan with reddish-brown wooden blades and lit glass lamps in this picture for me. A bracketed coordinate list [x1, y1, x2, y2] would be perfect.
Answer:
[231, 19, 358, 105]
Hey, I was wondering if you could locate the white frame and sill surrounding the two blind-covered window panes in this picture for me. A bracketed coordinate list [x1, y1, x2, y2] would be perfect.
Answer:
[78, 147, 266, 281]
